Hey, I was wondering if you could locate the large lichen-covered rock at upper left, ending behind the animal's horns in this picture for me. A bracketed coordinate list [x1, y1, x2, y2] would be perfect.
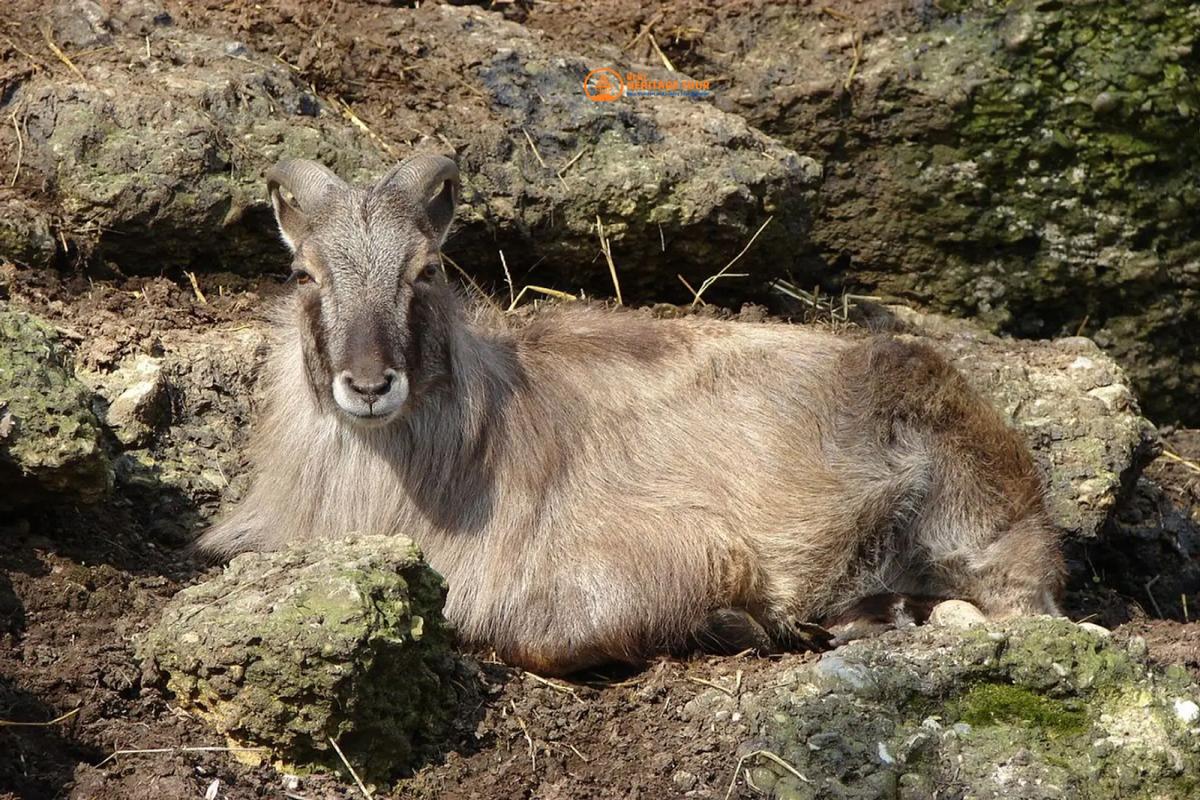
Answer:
[0, 0, 388, 273]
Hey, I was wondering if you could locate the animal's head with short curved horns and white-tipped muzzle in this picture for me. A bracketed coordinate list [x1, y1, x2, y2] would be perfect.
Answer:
[266, 156, 458, 426]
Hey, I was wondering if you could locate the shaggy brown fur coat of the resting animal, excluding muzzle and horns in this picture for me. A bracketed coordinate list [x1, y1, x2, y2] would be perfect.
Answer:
[192, 155, 1063, 673]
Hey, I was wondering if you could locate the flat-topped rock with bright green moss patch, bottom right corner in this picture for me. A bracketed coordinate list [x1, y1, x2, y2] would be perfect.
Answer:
[714, 618, 1200, 800]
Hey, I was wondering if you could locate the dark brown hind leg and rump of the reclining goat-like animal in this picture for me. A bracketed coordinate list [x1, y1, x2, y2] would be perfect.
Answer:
[848, 339, 1064, 618]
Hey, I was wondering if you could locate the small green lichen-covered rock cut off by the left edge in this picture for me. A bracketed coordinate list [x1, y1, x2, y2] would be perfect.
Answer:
[0, 307, 112, 507]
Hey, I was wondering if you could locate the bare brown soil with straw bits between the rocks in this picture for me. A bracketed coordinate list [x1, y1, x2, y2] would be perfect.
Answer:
[0, 0, 1200, 800]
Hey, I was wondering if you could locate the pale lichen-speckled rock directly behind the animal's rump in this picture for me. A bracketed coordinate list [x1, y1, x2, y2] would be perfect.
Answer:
[889, 307, 1159, 540]
